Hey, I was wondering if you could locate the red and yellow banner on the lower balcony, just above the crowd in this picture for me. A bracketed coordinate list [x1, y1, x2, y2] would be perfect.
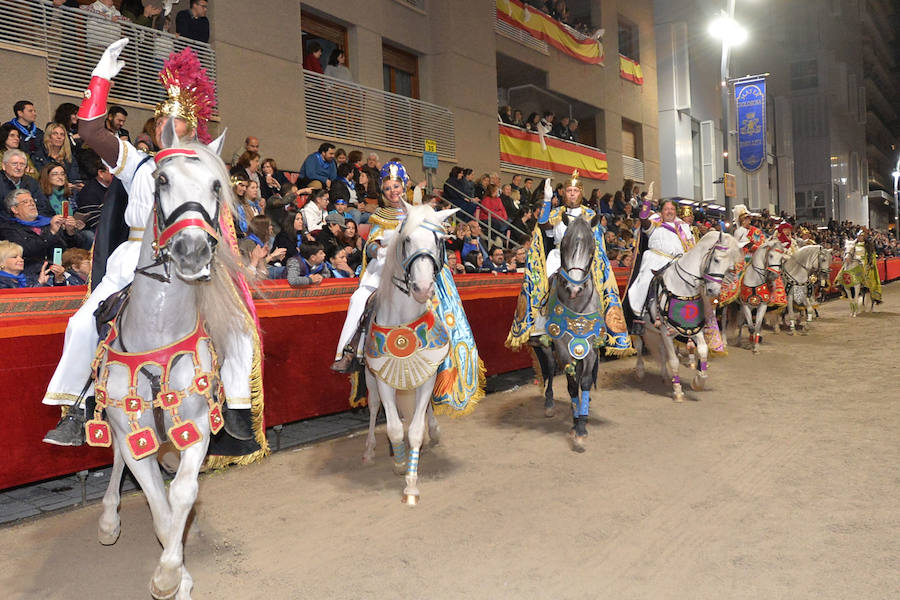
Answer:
[500, 125, 609, 181]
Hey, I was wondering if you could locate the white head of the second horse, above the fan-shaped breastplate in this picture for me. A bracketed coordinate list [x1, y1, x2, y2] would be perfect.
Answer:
[392, 204, 459, 304]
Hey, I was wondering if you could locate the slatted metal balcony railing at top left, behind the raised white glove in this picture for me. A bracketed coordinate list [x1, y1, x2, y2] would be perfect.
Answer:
[0, 0, 216, 110]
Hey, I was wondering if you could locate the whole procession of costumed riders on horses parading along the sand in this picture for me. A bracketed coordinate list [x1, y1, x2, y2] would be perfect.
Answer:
[21, 40, 881, 600]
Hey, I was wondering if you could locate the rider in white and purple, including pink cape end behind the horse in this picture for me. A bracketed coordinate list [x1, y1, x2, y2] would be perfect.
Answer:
[627, 194, 725, 352]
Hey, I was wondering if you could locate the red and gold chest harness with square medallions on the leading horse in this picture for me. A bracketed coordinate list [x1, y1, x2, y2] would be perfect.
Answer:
[85, 322, 224, 460]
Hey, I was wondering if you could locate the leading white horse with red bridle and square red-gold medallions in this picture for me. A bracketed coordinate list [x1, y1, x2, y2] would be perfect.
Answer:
[86, 135, 246, 600]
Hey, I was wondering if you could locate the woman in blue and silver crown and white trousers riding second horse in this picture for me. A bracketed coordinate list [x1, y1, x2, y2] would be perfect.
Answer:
[331, 162, 409, 373]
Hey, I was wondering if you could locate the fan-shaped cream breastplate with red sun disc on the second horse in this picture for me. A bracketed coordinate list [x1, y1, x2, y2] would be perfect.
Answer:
[366, 310, 450, 390]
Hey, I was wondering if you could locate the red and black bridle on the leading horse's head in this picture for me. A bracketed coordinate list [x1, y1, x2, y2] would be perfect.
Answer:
[134, 148, 222, 283]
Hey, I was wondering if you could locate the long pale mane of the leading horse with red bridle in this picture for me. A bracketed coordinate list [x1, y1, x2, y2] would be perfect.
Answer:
[175, 140, 248, 365]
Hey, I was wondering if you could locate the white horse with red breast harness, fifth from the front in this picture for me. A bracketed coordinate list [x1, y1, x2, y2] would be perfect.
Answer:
[736, 238, 784, 354]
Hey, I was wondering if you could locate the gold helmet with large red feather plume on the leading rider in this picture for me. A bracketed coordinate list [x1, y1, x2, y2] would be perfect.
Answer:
[155, 48, 216, 144]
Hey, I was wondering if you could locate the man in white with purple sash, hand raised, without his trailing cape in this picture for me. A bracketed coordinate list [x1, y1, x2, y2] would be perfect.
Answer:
[628, 200, 694, 321]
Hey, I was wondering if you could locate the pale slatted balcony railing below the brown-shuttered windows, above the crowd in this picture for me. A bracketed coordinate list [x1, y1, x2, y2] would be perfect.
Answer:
[303, 71, 456, 161]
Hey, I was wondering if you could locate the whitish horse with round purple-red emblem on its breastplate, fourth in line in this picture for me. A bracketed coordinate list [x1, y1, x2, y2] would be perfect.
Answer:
[635, 231, 741, 402]
